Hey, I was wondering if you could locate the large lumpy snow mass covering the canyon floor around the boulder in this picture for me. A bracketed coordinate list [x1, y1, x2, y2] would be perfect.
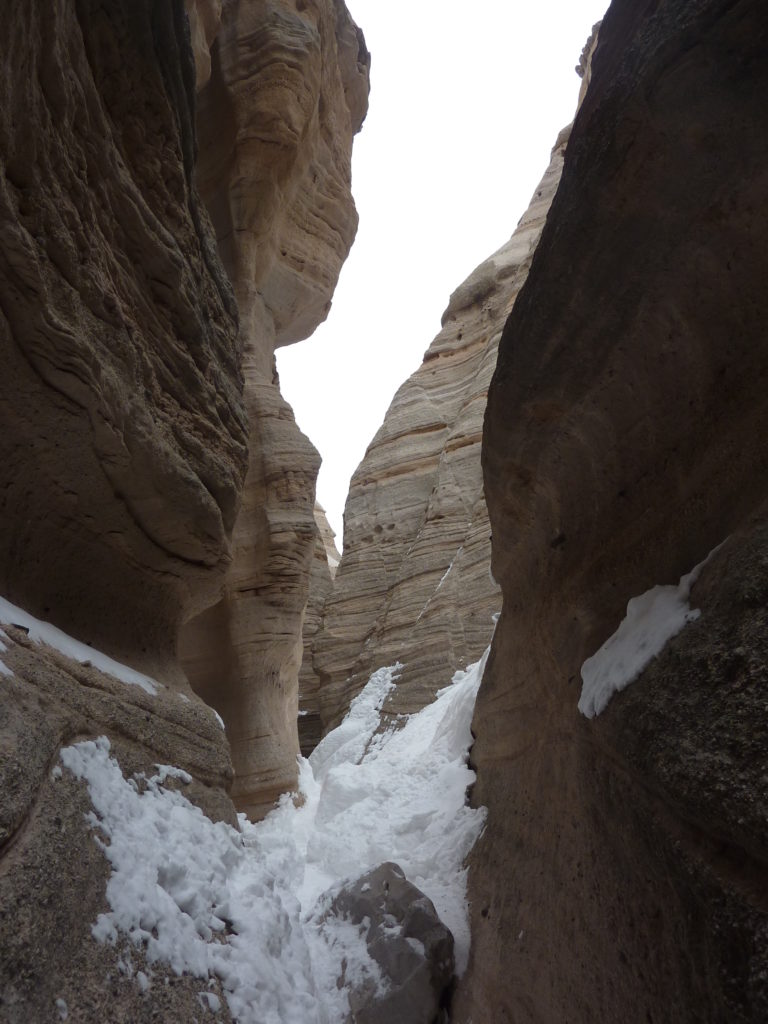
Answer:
[61, 652, 487, 1024]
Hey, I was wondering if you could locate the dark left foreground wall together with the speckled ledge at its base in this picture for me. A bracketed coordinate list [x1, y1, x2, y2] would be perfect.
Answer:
[0, 0, 243, 1024]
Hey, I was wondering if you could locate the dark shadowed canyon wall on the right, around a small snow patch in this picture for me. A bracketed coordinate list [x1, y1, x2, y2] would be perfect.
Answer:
[454, 0, 768, 1024]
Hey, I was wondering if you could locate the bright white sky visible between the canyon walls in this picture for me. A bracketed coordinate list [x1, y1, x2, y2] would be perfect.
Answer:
[278, 0, 607, 547]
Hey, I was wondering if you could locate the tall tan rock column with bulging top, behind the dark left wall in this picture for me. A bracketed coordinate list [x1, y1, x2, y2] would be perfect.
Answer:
[180, 0, 370, 815]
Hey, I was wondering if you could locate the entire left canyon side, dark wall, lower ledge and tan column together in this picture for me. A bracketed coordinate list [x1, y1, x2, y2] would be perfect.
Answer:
[0, 0, 369, 1011]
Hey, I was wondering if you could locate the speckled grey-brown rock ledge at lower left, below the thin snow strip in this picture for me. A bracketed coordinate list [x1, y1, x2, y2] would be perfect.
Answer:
[0, 626, 236, 1024]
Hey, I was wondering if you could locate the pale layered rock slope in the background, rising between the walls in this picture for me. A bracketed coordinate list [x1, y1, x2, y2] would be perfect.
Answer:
[313, 129, 568, 730]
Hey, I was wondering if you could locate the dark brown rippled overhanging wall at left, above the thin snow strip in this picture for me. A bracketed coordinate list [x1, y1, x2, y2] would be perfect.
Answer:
[0, 0, 247, 678]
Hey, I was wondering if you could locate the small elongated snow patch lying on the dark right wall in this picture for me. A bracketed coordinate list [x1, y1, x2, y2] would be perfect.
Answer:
[579, 548, 718, 718]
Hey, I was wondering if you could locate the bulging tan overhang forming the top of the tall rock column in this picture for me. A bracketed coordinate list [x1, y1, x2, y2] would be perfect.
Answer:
[198, 0, 370, 348]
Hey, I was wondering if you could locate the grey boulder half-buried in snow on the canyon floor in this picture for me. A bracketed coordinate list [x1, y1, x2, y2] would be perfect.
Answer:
[329, 863, 454, 1024]
